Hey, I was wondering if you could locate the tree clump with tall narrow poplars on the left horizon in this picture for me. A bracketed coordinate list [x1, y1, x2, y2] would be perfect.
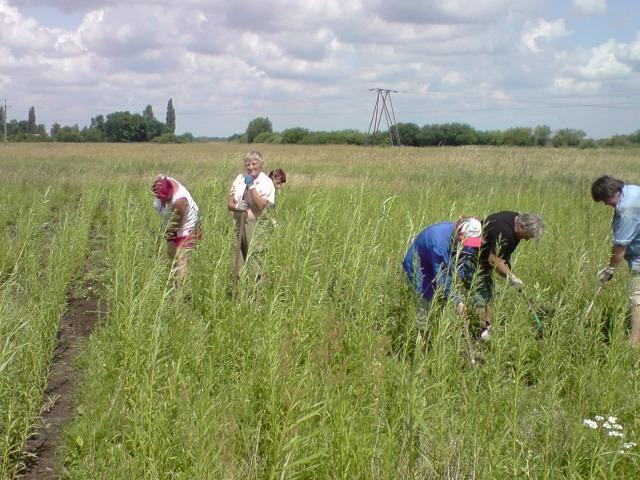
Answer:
[0, 99, 194, 143]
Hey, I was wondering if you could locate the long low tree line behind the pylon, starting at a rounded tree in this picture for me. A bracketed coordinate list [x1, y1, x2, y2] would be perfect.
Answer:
[235, 117, 640, 148]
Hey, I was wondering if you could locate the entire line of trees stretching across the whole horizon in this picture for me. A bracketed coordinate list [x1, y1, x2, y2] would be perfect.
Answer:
[0, 106, 640, 148]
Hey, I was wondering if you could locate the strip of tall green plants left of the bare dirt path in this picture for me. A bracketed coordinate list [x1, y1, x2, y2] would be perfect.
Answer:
[0, 189, 97, 478]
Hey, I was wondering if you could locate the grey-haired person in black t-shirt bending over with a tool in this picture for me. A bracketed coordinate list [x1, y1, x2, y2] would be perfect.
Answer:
[475, 211, 544, 340]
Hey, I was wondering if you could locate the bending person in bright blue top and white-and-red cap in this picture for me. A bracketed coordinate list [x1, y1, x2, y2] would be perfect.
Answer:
[402, 217, 482, 329]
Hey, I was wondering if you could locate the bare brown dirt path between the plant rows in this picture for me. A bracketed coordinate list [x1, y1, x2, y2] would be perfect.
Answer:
[21, 291, 100, 479]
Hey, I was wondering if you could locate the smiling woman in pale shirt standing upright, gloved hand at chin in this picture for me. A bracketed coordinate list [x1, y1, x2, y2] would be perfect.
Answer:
[227, 151, 276, 281]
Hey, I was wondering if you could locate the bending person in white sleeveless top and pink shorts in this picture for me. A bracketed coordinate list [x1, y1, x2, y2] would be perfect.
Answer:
[151, 174, 202, 284]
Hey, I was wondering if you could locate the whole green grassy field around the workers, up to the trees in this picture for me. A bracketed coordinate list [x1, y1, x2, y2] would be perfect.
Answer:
[0, 144, 640, 479]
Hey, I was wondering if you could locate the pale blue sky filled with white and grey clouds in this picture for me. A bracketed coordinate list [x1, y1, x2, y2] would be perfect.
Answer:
[0, 0, 640, 138]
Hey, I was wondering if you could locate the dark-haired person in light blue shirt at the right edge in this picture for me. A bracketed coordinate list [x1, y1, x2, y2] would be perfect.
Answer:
[591, 175, 640, 347]
